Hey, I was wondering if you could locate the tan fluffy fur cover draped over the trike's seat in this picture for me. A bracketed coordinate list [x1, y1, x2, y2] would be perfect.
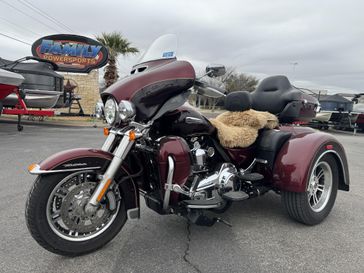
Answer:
[210, 109, 278, 148]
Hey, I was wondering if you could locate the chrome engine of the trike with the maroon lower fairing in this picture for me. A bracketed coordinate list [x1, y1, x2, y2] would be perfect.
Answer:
[159, 136, 238, 201]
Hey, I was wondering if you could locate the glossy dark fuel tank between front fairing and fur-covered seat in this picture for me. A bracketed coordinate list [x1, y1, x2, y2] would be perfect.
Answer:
[157, 106, 215, 138]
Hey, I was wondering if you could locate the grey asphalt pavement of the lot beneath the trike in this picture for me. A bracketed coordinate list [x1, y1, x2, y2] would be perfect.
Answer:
[0, 122, 364, 273]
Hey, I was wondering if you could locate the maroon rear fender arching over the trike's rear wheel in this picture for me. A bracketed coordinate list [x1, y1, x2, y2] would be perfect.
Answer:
[272, 128, 349, 192]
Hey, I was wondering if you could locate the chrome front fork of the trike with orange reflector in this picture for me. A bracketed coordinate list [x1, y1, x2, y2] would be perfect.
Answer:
[85, 130, 135, 213]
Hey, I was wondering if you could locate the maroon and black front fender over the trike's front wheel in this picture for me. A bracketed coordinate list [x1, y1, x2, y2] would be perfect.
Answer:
[28, 148, 139, 218]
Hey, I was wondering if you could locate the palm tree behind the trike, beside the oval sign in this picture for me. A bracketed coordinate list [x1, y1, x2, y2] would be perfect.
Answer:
[96, 31, 139, 87]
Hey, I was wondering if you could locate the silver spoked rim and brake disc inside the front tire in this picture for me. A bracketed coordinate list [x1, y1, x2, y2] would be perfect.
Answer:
[47, 171, 121, 241]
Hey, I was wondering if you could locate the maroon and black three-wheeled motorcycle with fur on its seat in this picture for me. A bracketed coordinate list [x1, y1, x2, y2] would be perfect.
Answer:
[26, 35, 349, 256]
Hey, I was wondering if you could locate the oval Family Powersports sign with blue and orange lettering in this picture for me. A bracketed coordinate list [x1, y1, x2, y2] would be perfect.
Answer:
[32, 34, 108, 73]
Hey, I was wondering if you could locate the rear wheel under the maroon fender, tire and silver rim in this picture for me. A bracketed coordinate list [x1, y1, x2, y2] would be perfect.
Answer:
[282, 154, 339, 225]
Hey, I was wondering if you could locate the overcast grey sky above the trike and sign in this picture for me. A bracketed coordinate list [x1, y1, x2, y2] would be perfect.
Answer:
[0, 0, 364, 93]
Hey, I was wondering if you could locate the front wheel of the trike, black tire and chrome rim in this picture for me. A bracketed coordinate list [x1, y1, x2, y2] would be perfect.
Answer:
[25, 171, 127, 256]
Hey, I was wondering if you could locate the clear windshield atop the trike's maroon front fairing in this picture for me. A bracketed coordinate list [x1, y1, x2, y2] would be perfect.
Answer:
[138, 34, 177, 64]
